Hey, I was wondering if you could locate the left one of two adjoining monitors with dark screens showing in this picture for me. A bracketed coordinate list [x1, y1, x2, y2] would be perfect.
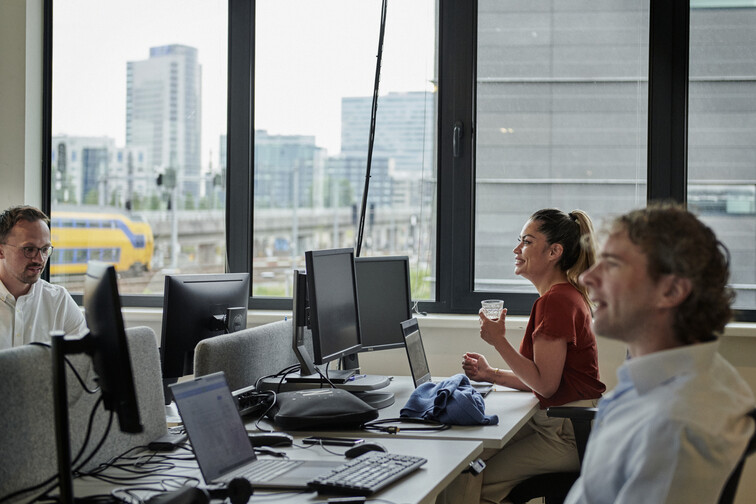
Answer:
[305, 249, 362, 372]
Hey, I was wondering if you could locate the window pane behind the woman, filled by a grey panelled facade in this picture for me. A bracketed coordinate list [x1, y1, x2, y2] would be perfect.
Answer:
[474, 0, 649, 298]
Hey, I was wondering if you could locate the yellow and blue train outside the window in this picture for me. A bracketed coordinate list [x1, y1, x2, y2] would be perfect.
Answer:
[50, 211, 155, 275]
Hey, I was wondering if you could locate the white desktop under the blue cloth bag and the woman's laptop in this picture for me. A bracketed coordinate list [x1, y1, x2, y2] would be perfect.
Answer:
[247, 376, 538, 448]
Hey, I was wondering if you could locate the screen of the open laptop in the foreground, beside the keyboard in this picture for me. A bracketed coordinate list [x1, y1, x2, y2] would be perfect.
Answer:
[171, 373, 256, 483]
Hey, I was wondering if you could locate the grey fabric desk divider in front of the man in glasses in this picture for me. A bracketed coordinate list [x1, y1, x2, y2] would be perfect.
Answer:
[0, 327, 167, 502]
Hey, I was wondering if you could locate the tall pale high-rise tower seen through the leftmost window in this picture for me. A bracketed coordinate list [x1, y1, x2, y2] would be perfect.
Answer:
[126, 44, 202, 202]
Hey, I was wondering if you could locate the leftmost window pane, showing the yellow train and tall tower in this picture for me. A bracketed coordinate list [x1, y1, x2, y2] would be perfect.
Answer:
[50, 0, 228, 294]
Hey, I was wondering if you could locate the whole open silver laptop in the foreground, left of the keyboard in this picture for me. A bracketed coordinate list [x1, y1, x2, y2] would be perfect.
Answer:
[171, 371, 343, 490]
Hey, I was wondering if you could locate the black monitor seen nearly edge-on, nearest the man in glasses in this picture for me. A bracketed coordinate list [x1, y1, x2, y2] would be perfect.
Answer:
[84, 261, 143, 433]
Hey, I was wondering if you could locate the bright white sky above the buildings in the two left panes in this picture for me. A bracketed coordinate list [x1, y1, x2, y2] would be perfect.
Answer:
[53, 0, 435, 171]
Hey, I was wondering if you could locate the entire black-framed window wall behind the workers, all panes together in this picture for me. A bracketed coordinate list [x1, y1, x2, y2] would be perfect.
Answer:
[46, 0, 756, 319]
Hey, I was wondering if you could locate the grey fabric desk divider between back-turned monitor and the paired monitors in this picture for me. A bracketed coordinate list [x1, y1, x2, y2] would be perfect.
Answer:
[194, 320, 312, 390]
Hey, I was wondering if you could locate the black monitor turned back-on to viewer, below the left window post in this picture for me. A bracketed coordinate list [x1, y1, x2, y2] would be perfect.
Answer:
[160, 273, 249, 404]
